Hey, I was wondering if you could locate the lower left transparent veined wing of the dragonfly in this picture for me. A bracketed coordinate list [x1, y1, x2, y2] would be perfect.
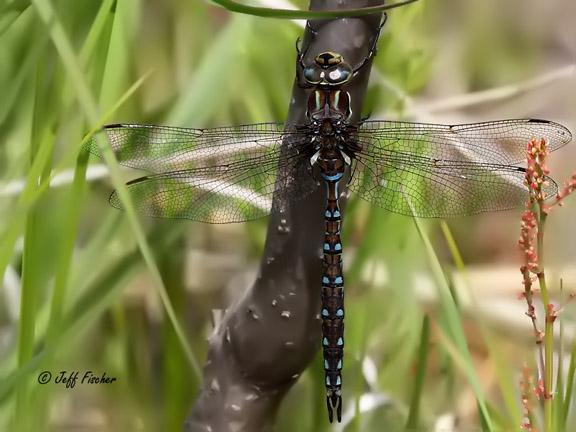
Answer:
[110, 145, 317, 223]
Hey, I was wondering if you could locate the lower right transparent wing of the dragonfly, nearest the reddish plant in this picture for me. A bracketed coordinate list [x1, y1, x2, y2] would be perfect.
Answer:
[349, 148, 558, 218]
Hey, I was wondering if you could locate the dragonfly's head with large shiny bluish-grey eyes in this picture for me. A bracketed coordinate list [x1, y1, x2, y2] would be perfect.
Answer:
[303, 51, 353, 87]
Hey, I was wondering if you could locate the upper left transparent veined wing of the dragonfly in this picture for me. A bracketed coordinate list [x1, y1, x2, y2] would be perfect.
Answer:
[86, 123, 297, 173]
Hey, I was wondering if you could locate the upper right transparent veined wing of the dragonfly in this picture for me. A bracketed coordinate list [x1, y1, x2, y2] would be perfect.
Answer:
[358, 119, 572, 165]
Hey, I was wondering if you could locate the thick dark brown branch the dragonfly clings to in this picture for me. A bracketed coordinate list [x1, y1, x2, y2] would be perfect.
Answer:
[185, 0, 382, 432]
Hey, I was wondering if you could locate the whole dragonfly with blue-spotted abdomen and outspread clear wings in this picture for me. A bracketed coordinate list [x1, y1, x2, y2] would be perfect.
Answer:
[88, 31, 571, 422]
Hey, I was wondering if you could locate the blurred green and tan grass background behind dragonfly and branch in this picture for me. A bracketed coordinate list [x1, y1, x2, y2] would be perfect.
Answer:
[0, 0, 576, 431]
